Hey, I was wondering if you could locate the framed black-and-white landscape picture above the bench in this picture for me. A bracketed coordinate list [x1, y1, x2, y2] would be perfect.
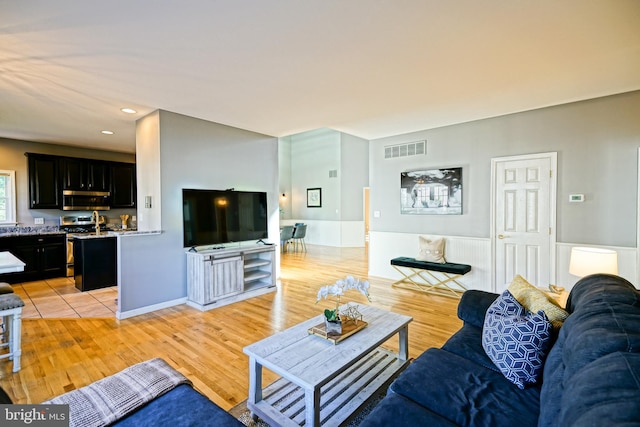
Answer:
[400, 168, 462, 215]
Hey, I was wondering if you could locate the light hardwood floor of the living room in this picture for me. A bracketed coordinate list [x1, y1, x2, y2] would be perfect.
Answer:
[0, 246, 461, 410]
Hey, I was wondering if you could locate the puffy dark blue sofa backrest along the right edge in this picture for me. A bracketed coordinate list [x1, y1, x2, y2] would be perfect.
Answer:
[540, 274, 640, 427]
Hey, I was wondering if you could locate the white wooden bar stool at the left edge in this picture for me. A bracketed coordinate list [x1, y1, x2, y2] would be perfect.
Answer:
[0, 292, 24, 372]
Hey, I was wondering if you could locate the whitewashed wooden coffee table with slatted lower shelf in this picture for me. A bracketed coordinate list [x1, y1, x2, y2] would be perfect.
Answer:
[244, 305, 413, 426]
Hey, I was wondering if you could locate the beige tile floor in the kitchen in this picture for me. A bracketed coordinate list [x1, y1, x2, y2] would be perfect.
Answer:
[13, 277, 118, 319]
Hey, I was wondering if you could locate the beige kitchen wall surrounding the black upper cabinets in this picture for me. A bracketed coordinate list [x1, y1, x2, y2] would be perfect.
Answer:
[0, 138, 136, 226]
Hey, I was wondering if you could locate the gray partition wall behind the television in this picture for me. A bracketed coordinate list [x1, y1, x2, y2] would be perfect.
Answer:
[120, 111, 279, 312]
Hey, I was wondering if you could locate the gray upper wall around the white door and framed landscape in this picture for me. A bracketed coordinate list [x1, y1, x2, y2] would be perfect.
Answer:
[370, 91, 640, 247]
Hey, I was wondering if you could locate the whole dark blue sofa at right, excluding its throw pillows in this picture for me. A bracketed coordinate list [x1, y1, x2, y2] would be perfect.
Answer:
[361, 274, 640, 427]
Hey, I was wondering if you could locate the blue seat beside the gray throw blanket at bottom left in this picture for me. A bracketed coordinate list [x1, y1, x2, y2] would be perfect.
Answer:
[112, 384, 243, 427]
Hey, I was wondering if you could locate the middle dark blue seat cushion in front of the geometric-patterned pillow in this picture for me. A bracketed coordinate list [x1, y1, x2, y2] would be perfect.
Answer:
[390, 348, 540, 427]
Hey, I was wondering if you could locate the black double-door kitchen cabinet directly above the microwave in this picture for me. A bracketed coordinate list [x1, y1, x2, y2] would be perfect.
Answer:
[61, 157, 110, 191]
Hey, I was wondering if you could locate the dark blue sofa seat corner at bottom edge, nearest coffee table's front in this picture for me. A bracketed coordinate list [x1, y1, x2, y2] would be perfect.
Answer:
[360, 391, 456, 427]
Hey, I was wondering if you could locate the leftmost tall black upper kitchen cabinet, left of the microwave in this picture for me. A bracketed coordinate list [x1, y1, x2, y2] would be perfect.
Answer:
[27, 153, 62, 209]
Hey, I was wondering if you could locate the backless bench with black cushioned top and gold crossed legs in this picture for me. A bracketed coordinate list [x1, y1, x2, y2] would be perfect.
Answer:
[391, 257, 471, 298]
